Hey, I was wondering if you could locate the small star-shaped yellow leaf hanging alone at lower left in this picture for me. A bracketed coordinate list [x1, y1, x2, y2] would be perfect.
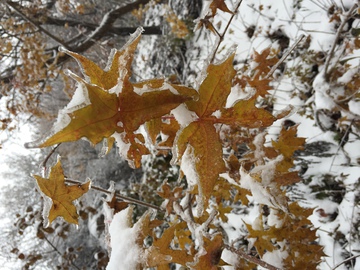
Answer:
[34, 159, 90, 224]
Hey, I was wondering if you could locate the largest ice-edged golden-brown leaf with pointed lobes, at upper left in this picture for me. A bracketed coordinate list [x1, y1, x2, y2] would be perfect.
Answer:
[28, 29, 196, 167]
